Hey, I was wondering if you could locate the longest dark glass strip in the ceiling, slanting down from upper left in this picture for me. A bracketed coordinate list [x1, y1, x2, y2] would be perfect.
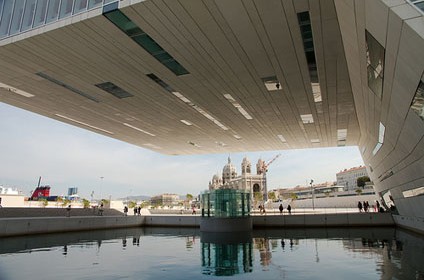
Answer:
[103, 9, 189, 76]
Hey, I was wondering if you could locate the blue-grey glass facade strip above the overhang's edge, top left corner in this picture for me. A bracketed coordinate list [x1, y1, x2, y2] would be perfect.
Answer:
[0, 0, 106, 39]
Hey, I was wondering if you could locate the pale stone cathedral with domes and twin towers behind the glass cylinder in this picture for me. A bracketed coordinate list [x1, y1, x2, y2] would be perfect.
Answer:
[209, 157, 267, 201]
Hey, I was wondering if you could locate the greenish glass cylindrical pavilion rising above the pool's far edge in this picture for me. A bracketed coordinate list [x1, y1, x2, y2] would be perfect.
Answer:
[201, 189, 251, 218]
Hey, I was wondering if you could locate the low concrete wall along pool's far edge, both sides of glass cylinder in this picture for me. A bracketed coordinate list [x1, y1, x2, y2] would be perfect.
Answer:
[0, 208, 395, 237]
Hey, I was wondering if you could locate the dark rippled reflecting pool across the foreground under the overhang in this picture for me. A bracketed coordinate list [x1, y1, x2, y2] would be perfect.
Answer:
[0, 228, 424, 280]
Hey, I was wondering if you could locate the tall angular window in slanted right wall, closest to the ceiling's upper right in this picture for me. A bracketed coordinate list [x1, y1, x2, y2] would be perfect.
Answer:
[365, 30, 385, 98]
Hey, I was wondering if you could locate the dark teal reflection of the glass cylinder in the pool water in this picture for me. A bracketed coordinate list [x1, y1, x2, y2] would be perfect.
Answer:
[200, 232, 253, 276]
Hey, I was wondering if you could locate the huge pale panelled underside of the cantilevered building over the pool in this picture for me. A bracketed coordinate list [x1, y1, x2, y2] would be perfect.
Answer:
[0, 0, 359, 154]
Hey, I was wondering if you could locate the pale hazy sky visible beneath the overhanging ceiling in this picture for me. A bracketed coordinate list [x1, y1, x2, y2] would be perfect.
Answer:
[0, 102, 363, 199]
